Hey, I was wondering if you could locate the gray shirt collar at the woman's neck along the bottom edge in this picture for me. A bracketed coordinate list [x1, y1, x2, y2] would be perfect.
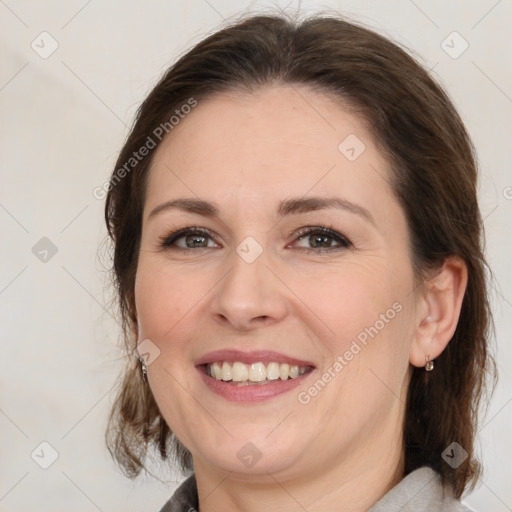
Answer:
[160, 467, 471, 512]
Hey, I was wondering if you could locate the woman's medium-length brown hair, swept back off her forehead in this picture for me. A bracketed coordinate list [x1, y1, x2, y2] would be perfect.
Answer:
[105, 14, 494, 497]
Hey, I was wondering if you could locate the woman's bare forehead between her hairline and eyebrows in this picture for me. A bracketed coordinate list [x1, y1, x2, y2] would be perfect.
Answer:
[146, 86, 392, 218]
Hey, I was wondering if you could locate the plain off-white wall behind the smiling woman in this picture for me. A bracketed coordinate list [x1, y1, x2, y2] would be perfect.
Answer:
[0, 0, 512, 512]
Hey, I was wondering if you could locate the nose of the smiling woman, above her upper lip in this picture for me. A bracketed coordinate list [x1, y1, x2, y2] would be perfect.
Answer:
[211, 245, 288, 331]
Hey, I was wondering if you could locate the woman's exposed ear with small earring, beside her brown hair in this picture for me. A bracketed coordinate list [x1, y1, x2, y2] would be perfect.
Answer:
[409, 256, 468, 367]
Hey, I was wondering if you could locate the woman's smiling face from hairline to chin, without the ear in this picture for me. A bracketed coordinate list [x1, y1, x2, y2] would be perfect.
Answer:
[135, 86, 417, 481]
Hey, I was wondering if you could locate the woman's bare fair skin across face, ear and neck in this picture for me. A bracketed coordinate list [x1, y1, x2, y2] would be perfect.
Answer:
[135, 85, 467, 512]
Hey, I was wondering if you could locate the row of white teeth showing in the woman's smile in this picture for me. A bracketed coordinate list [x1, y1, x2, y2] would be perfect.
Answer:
[206, 361, 311, 384]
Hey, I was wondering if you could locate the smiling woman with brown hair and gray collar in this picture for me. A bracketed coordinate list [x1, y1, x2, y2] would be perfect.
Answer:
[106, 12, 492, 512]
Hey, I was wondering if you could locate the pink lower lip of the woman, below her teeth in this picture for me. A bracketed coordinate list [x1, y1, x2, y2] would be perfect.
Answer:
[196, 366, 314, 402]
